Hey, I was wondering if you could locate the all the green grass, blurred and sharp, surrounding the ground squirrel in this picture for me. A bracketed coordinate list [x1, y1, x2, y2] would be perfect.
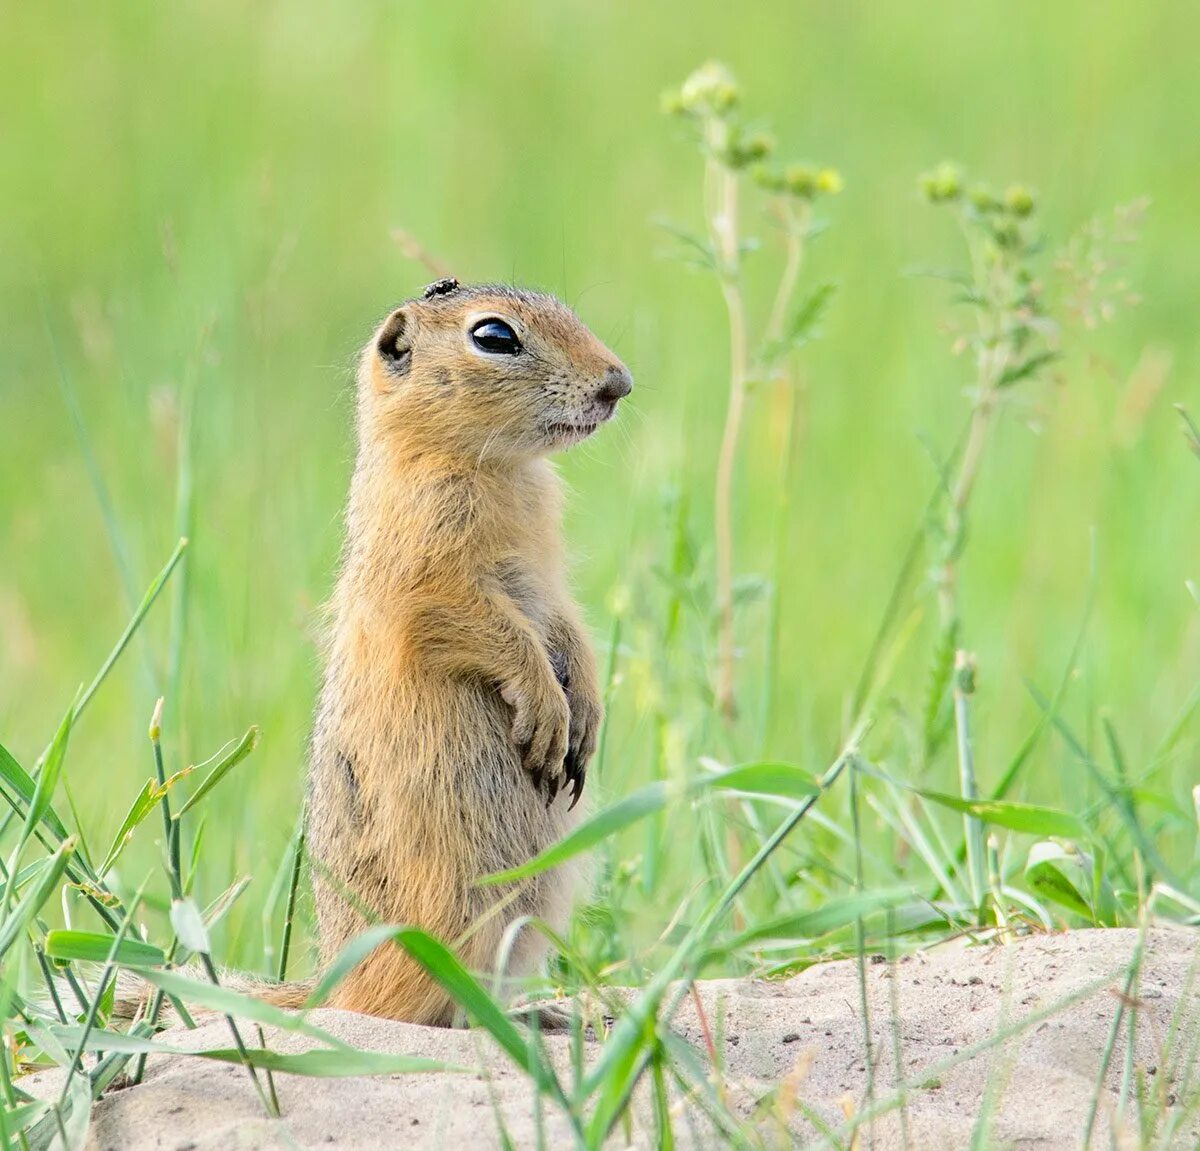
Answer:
[0, 2, 1200, 1146]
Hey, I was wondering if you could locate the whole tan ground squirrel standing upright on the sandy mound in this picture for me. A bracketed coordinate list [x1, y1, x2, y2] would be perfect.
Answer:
[308, 280, 632, 1024]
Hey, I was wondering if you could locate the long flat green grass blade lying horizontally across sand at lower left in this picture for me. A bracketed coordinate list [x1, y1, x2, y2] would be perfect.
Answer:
[50, 1026, 458, 1079]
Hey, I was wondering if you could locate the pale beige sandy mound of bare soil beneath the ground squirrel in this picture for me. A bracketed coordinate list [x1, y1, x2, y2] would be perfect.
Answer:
[26, 930, 1200, 1151]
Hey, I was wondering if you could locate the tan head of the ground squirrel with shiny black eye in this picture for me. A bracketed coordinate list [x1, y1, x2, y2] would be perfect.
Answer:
[359, 280, 634, 462]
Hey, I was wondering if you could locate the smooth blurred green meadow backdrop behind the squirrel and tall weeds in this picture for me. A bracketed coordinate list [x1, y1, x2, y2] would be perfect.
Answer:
[0, 0, 1200, 964]
